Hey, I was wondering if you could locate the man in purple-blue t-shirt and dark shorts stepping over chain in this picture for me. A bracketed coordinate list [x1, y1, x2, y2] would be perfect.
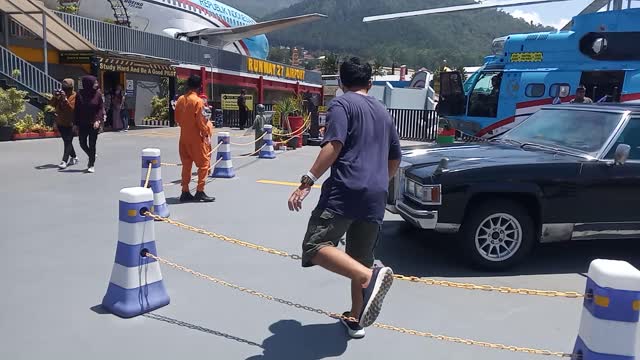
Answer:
[289, 58, 401, 338]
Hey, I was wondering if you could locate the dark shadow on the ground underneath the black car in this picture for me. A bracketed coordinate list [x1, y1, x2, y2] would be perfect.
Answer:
[375, 221, 640, 277]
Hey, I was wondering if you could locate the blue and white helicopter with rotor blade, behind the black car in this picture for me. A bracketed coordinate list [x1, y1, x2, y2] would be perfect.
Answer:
[364, 0, 640, 137]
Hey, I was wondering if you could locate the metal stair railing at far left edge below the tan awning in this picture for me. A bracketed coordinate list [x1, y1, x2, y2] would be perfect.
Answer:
[0, 46, 62, 96]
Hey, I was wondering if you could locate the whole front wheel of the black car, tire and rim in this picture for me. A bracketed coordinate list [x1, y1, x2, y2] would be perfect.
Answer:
[460, 200, 536, 271]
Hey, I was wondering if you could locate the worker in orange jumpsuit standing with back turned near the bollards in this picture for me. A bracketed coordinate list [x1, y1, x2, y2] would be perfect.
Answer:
[175, 75, 215, 202]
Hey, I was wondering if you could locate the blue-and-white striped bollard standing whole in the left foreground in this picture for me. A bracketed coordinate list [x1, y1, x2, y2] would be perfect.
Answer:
[102, 187, 169, 318]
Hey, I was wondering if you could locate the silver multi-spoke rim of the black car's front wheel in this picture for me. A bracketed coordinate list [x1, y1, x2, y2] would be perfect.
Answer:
[475, 213, 522, 262]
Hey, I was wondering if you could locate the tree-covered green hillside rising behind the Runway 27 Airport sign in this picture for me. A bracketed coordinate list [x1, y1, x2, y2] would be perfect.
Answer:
[265, 0, 551, 70]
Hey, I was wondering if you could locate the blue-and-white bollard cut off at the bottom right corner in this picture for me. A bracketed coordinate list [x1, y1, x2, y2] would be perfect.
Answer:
[573, 259, 640, 360]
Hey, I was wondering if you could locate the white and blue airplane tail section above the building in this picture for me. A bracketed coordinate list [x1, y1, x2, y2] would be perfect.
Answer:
[45, 0, 326, 59]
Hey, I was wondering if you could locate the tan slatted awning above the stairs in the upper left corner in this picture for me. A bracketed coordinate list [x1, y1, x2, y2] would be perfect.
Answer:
[0, 0, 96, 51]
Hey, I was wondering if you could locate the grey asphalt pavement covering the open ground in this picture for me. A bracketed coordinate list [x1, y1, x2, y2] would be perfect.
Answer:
[0, 129, 640, 360]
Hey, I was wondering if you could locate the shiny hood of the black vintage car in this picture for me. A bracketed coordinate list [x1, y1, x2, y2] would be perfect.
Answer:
[402, 143, 581, 177]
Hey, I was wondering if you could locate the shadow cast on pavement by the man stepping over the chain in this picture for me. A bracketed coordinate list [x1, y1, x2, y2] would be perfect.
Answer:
[247, 320, 349, 360]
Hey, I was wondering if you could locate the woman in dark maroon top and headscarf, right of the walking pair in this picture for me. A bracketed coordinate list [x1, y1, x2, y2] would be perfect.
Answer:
[75, 75, 105, 173]
